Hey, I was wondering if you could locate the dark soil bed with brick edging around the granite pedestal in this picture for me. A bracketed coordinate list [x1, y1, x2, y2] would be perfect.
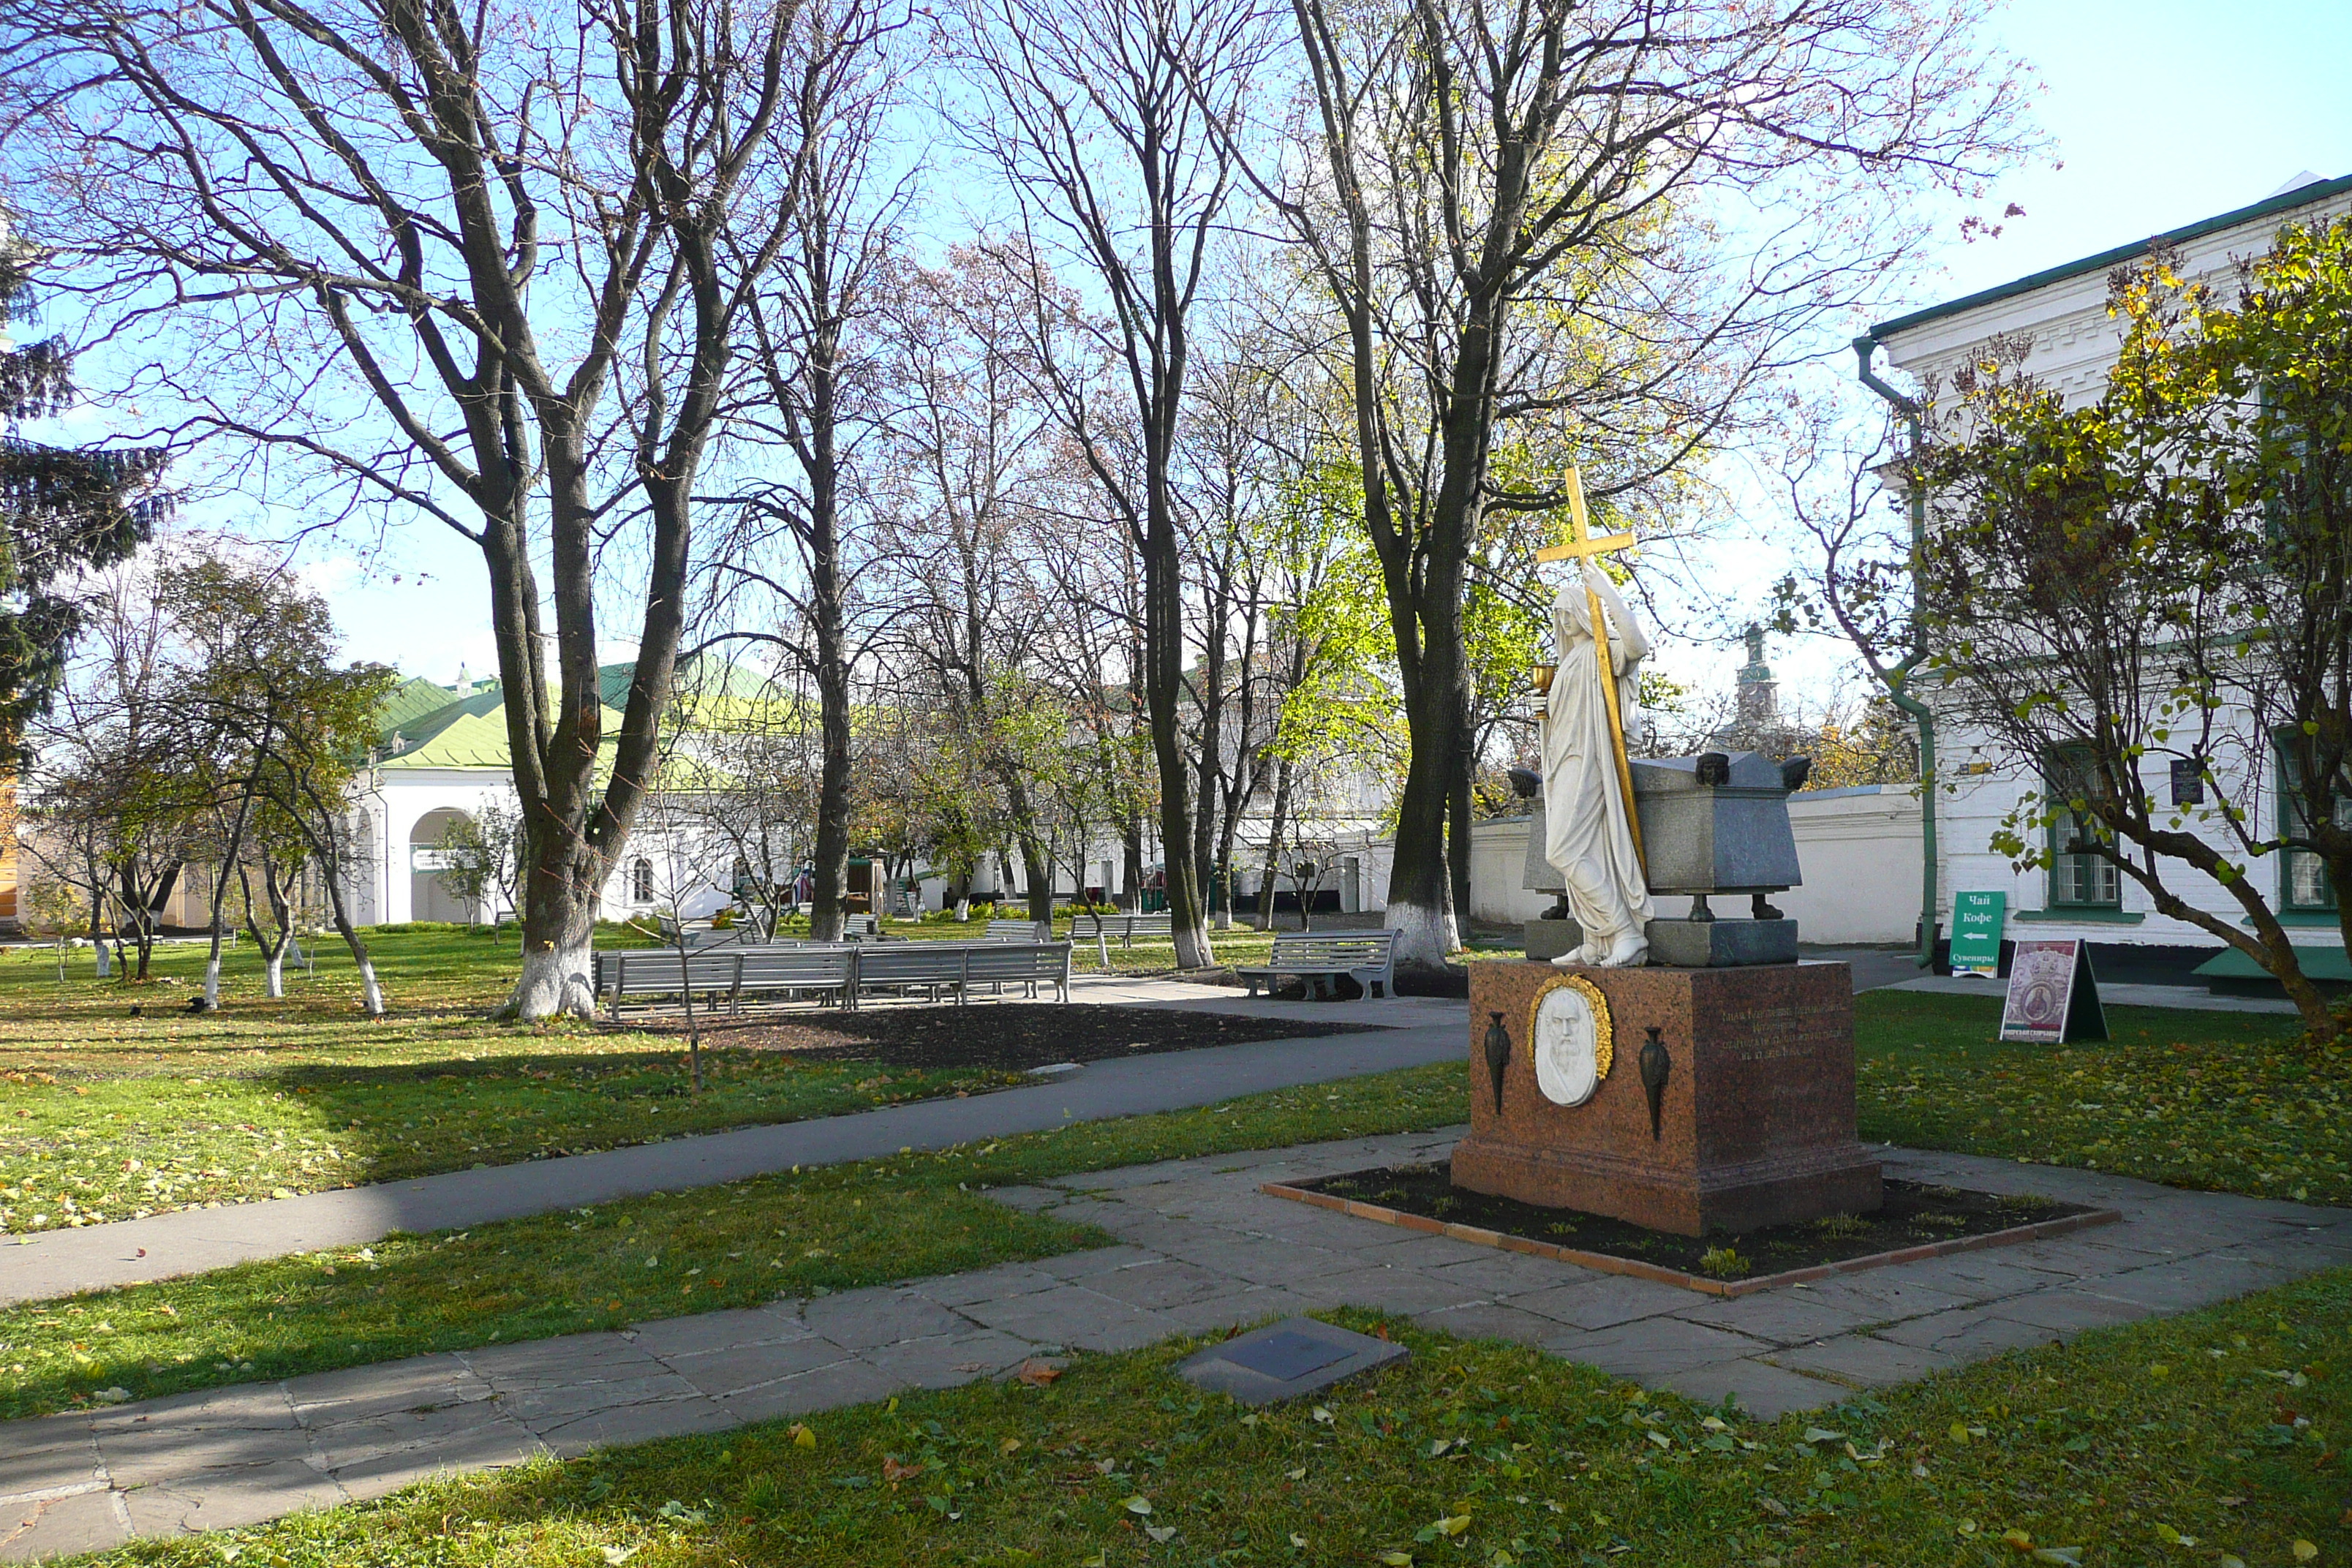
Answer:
[1294, 1161, 2091, 1279]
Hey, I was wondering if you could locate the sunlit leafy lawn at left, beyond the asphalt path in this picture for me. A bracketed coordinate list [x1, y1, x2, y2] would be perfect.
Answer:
[0, 921, 1308, 1235]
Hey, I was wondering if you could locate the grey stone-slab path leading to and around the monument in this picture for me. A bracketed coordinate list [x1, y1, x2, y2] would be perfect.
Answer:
[0, 1128, 2352, 1561]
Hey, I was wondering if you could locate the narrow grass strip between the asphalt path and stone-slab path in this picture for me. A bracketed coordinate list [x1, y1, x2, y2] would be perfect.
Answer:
[0, 1065, 1468, 1420]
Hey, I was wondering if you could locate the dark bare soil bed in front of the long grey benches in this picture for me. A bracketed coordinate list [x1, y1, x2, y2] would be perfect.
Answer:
[668, 1001, 1369, 1067]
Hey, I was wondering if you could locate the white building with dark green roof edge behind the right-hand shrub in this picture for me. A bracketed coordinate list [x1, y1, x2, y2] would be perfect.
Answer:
[1853, 176, 2352, 978]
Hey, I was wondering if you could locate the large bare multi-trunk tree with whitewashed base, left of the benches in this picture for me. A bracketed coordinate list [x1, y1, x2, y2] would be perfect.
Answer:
[0, 0, 818, 1018]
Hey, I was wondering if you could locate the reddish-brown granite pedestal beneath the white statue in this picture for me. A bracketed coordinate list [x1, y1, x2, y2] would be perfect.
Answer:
[1453, 962, 1880, 1237]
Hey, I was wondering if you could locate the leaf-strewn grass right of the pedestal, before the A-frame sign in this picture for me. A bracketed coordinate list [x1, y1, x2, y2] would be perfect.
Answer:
[1853, 990, 2352, 1204]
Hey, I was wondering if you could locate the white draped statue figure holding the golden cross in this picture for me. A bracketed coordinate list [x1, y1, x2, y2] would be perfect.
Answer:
[1543, 559, 1656, 966]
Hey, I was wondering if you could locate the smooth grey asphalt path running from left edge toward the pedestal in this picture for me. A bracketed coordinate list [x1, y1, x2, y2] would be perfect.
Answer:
[0, 980, 1466, 1305]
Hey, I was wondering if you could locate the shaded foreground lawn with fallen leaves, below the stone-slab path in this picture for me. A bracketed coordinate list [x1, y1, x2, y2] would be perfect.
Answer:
[64, 1270, 2352, 1568]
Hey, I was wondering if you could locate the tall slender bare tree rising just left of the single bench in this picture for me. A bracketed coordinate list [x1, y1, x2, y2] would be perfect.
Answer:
[955, 0, 1263, 968]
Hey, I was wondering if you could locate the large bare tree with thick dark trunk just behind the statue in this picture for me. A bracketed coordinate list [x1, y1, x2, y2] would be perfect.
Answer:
[1218, 0, 2021, 966]
